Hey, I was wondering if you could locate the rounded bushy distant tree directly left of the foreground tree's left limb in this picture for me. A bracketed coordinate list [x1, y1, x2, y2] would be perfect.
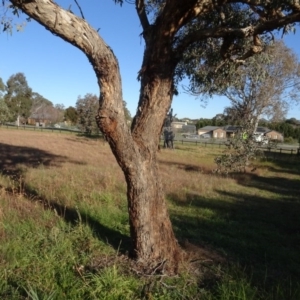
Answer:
[76, 94, 99, 135]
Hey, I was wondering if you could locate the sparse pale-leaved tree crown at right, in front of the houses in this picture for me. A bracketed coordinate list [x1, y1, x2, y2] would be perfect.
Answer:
[222, 41, 300, 134]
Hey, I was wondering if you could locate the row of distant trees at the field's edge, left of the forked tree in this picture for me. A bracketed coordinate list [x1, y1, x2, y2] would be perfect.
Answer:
[0, 73, 131, 135]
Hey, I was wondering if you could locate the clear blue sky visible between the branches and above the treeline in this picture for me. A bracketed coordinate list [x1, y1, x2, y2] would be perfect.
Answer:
[0, 0, 300, 119]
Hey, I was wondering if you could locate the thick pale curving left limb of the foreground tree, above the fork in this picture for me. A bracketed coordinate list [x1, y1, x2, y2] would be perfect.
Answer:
[10, 0, 133, 169]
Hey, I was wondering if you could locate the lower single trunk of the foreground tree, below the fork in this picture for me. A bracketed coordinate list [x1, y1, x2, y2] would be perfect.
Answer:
[125, 149, 179, 272]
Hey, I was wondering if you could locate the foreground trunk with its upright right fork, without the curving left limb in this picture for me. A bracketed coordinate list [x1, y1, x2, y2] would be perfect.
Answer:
[124, 71, 180, 272]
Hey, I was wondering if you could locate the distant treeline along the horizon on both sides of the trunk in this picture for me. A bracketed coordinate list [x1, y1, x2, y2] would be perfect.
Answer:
[0, 73, 300, 141]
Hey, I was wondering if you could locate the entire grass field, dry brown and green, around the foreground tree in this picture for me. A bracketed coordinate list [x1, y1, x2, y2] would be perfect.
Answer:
[0, 129, 300, 300]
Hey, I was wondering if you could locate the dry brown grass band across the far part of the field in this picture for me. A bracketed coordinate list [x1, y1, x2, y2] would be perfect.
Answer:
[0, 129, 224, 197]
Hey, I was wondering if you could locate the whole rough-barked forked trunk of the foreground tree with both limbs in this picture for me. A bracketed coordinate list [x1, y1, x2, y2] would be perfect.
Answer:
[11, 0, 180, 273]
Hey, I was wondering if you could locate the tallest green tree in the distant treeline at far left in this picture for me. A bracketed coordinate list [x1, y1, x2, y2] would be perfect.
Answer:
[4, 73, 32, 120]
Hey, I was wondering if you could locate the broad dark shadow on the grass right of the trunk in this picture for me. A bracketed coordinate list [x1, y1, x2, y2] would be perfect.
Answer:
[170, 183, 300, 290]
